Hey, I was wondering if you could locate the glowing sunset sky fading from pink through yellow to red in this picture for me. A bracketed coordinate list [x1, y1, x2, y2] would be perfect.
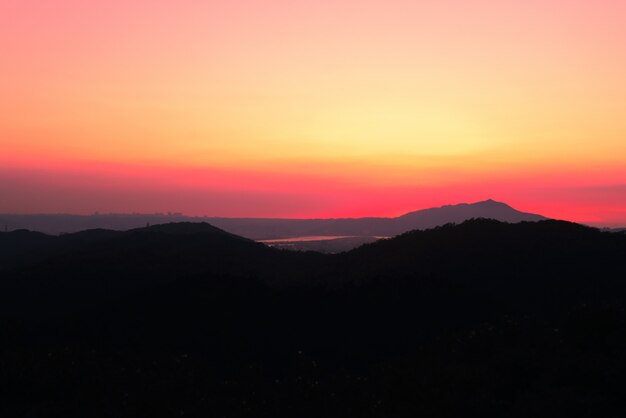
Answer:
[0, 0, 626, 226]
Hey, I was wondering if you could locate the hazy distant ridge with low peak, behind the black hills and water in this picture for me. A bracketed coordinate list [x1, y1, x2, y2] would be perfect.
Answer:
[0, 200, 546, 240]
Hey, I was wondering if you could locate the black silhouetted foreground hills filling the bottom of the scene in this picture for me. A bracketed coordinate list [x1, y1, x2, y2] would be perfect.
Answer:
[0, 220, 626, 417]
